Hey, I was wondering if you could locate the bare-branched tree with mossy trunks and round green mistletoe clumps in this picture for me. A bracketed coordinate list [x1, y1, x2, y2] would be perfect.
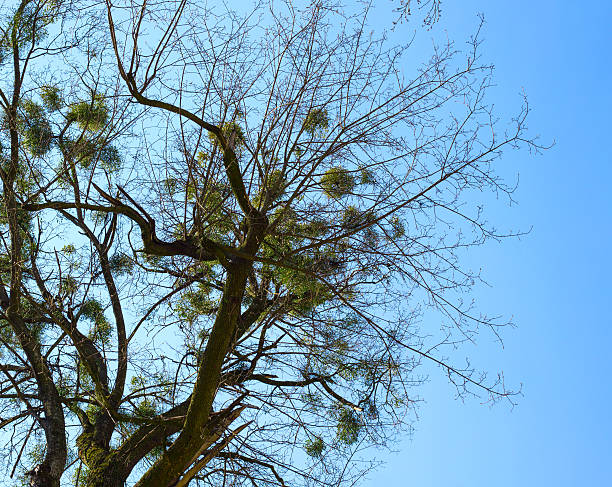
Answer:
[0, 0, 538, 487]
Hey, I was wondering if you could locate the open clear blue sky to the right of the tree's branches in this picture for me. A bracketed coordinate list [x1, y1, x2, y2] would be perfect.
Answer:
[365, 0, 612, 487]
